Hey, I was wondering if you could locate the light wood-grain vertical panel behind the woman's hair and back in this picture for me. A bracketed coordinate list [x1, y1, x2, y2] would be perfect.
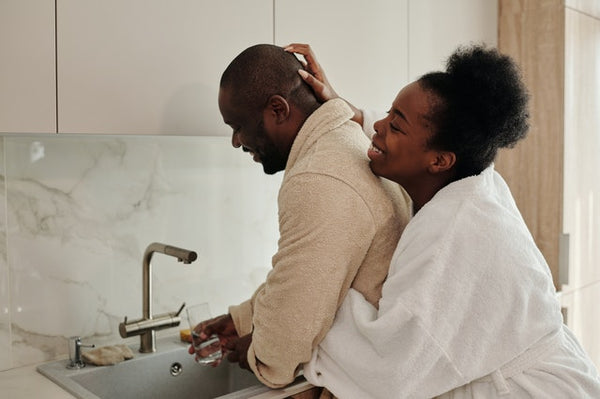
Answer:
[496, 0, 565, 289]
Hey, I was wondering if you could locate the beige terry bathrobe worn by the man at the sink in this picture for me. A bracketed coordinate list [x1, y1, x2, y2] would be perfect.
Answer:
[229, 99, 410, 387]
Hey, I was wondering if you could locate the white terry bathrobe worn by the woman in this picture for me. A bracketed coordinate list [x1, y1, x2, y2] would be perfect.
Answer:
[304, 166, 600, 399]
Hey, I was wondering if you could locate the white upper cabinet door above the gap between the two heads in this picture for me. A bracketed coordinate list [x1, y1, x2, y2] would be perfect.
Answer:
[275, 0, 408, 112]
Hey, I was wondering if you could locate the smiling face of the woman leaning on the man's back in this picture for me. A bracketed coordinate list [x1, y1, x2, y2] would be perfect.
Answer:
[367, 81, 437, 190]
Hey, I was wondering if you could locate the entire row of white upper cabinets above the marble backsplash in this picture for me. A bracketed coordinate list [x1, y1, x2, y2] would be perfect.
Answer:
[0, 0, 497, 135]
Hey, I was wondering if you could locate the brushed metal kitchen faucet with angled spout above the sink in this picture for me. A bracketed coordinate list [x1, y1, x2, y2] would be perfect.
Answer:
[119, 242, 198, 353]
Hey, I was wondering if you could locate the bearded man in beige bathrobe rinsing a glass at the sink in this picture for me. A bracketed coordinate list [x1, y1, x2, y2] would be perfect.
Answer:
[190, 45, 410, 388]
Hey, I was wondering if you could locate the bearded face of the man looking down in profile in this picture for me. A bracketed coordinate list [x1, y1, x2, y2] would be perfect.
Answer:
[219, 88, 288, 175]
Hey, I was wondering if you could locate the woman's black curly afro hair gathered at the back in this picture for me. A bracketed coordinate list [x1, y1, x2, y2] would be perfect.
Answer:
[419, 45, 529, 178]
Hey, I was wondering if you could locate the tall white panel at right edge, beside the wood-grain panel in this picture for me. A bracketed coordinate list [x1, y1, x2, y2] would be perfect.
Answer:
[562, 0, 600, 365]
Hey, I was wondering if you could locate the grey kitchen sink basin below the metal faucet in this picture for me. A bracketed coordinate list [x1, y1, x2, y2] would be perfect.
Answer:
[37, 338, 307, 399]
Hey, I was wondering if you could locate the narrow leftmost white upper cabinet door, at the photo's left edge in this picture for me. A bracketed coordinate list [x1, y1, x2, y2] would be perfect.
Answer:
[0, 0, 56, 133]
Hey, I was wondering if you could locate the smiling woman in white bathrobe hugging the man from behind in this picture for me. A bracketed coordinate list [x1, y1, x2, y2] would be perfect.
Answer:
[287, 44, 600, 399]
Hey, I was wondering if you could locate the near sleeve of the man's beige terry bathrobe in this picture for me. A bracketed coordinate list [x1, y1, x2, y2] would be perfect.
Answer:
[248, 173, 375, 388]
